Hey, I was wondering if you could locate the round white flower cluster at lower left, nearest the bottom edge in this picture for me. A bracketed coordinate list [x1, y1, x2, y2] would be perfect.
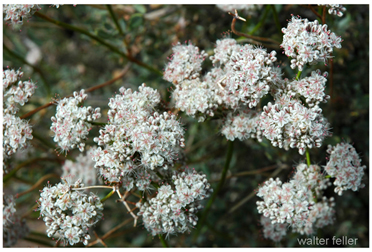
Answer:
[38, 178, 103, 245]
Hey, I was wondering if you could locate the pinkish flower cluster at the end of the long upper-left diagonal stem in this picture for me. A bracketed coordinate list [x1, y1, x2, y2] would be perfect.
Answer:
[164, 42, 208, 85]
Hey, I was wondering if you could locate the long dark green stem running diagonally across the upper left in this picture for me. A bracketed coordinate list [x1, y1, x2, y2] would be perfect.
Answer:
[34, 12, 163, 76]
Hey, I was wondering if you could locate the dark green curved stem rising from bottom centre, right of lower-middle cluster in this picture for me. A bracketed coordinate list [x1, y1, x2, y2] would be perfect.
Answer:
[193, 141, 234, 242]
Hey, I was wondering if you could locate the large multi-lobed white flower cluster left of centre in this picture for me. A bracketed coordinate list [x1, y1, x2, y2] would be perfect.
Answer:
[93, 84, 185, 182]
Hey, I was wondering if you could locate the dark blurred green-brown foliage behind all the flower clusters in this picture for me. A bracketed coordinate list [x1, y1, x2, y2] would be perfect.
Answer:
[3, 4, 369, 247]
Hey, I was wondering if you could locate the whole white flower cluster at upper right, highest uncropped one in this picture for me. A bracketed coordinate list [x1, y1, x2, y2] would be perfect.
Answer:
[281, 16, 342, 71]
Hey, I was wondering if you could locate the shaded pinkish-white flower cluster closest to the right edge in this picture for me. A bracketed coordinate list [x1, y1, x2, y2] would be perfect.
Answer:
[324, 143, 366, 195]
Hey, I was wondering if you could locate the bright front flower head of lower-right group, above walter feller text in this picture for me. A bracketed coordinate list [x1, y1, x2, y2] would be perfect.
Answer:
[257, 178, 314, 228]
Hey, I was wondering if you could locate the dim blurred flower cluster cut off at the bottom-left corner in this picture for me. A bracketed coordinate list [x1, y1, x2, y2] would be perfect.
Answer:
[3, 196, 28, 247]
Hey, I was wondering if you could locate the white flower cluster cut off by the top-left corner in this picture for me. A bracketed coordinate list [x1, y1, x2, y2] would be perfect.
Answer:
[3, 4, 41, 25]
